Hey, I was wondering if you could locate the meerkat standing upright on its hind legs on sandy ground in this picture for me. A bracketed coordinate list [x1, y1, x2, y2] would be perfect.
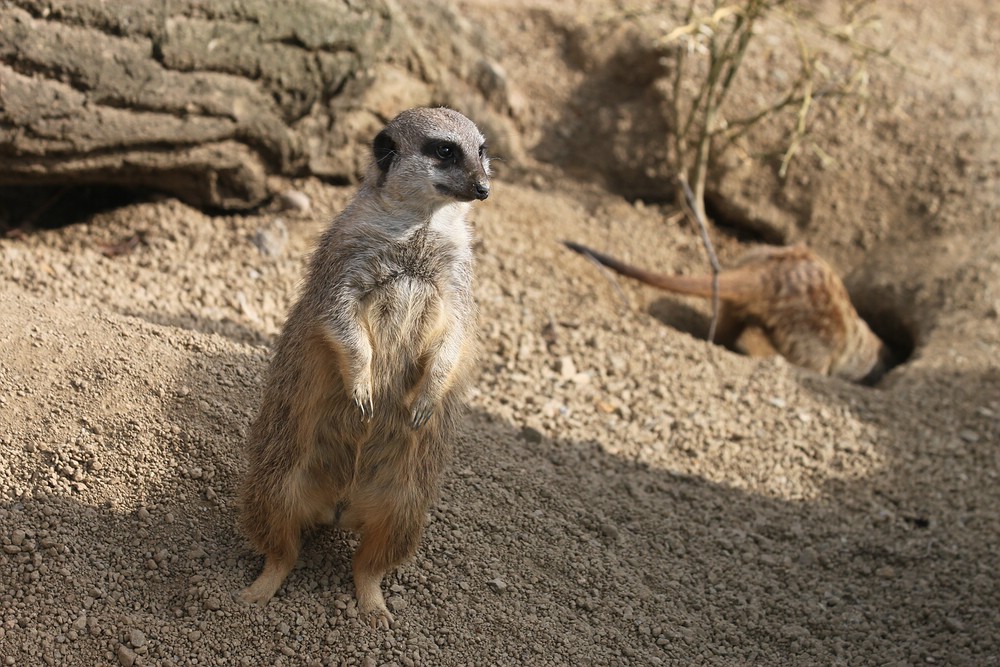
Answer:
[240, 108, 490, 627]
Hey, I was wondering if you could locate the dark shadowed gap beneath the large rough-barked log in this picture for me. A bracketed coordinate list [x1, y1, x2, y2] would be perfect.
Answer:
[0, 185, 156, 236]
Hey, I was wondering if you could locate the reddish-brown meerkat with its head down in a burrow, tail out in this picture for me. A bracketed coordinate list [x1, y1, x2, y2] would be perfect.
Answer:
[565, 241, 893, 384]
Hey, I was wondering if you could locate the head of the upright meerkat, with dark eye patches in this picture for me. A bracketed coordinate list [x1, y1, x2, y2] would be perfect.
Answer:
[372, 107, 490, 210]
